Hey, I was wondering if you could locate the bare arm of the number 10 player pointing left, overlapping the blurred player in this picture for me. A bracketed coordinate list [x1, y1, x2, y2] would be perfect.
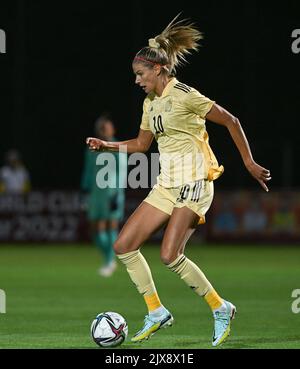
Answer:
[86, 129, 154, 154]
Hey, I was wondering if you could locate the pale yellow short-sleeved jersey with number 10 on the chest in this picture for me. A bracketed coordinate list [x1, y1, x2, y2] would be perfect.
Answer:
[140, 78, 224, 188]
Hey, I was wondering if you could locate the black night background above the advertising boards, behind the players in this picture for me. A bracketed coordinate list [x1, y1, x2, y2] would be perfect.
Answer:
[0, 0, 300, 190]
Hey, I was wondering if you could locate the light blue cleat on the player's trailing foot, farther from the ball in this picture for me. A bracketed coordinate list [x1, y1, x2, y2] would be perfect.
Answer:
[212, 300, 236, 346]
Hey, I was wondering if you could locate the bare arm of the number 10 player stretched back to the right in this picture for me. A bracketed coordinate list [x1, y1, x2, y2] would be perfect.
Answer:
[206, 103, 271, 192]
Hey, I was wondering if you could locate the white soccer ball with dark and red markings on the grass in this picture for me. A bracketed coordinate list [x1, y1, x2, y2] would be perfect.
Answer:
[91, 311, 128, 347]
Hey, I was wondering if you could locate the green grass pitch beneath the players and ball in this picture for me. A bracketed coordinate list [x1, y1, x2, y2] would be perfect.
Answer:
[0, 244, 300, 350]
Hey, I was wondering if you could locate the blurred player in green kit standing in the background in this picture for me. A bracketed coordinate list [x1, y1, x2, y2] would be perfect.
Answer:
[81, 115, 127, 277]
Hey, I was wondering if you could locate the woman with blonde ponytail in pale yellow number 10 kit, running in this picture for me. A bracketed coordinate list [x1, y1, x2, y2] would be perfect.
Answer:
[87, 17, 271, 346]
